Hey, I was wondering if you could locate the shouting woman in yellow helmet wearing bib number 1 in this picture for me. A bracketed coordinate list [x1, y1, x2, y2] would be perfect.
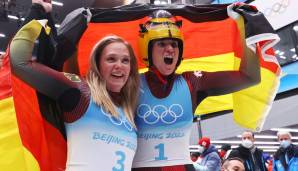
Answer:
[133, 4, 278, 171]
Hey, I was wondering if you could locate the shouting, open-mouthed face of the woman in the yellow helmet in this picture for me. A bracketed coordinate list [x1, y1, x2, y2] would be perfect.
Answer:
[152, 39, 179, 76]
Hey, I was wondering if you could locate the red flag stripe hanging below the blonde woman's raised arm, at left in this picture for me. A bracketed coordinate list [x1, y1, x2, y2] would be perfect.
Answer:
[12, 75, 66, 171]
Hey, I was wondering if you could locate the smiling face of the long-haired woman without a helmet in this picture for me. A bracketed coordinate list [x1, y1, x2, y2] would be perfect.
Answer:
[99, 42, 130, 92]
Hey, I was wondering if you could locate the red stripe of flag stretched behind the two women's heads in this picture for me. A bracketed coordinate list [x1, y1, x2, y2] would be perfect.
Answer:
[78, 17, 241, 75]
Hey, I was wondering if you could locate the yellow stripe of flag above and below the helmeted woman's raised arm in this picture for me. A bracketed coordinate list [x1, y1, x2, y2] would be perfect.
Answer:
[138, 53, 279, 130]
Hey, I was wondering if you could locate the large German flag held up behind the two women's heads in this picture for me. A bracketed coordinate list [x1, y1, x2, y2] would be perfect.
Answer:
[78, 4, 279, 130]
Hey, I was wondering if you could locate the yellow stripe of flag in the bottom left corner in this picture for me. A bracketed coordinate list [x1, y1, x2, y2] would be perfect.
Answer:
[0, 97, 40, 171]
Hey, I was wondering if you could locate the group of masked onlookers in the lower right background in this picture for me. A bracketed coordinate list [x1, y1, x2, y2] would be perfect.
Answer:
[190, 131, 298, 171]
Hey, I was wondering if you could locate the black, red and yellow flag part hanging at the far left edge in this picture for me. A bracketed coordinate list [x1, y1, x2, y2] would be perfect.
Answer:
[0, 42, 66, 171]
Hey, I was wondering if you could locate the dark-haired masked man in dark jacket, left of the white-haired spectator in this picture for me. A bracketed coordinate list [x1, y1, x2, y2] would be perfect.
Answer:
[228, 131, 267, 171]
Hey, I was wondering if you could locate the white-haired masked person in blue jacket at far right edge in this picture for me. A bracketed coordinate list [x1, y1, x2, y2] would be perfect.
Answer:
[273, 131, 298, 171]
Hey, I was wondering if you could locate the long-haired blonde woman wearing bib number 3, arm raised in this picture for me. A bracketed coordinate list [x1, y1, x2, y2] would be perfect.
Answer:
[8, 15, 139, 171]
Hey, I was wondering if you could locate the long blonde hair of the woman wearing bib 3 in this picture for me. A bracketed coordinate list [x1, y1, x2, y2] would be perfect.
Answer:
[86, 35, 140, 127]
